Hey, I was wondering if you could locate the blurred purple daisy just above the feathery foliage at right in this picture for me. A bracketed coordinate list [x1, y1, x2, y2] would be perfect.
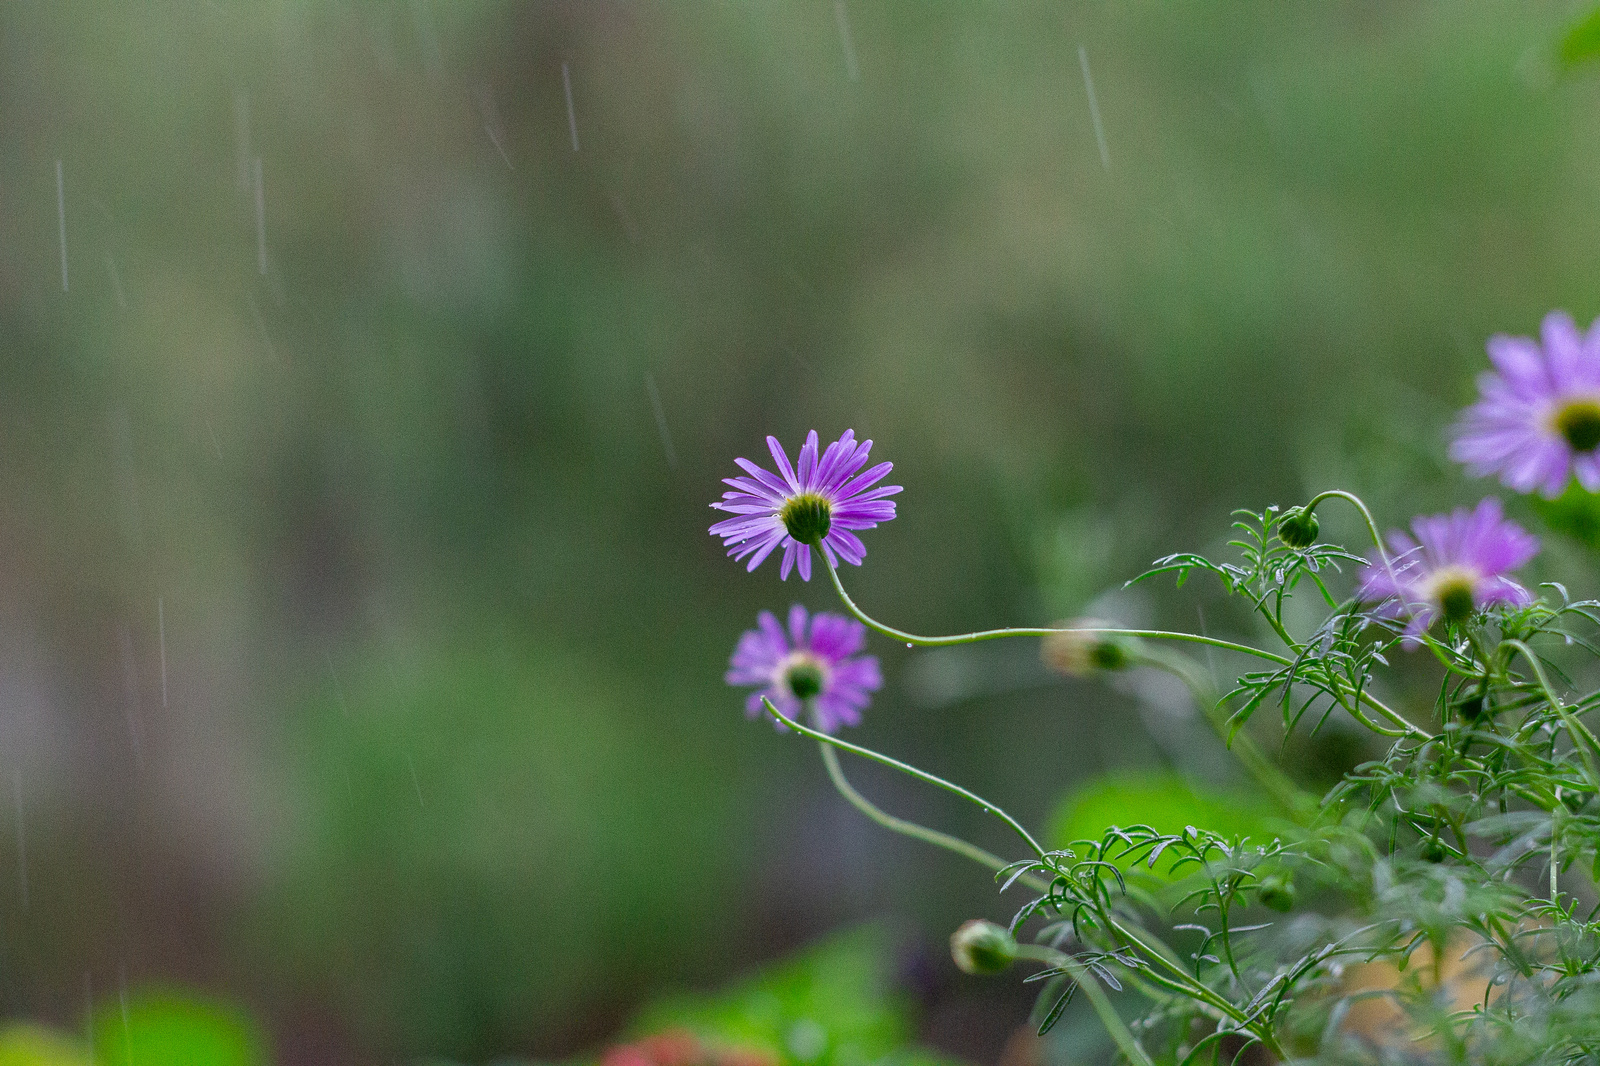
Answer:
[1360, 496, 1539, 642]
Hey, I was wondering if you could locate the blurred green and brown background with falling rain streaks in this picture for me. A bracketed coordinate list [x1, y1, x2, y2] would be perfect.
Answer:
[9, 0, 1600, 1063]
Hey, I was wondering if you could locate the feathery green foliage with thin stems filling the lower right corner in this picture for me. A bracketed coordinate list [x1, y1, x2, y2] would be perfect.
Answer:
[972, 509, 1600, 1066]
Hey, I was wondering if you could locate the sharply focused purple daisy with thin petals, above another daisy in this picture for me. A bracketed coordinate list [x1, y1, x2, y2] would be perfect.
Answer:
[710, 429, 901, 581]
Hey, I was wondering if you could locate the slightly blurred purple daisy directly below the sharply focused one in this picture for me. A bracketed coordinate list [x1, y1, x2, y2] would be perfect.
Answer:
[726, 603, 883, 733]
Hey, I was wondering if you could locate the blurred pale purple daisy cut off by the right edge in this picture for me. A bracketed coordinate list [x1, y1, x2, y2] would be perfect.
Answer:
[1450, 311, 1600, 498]
